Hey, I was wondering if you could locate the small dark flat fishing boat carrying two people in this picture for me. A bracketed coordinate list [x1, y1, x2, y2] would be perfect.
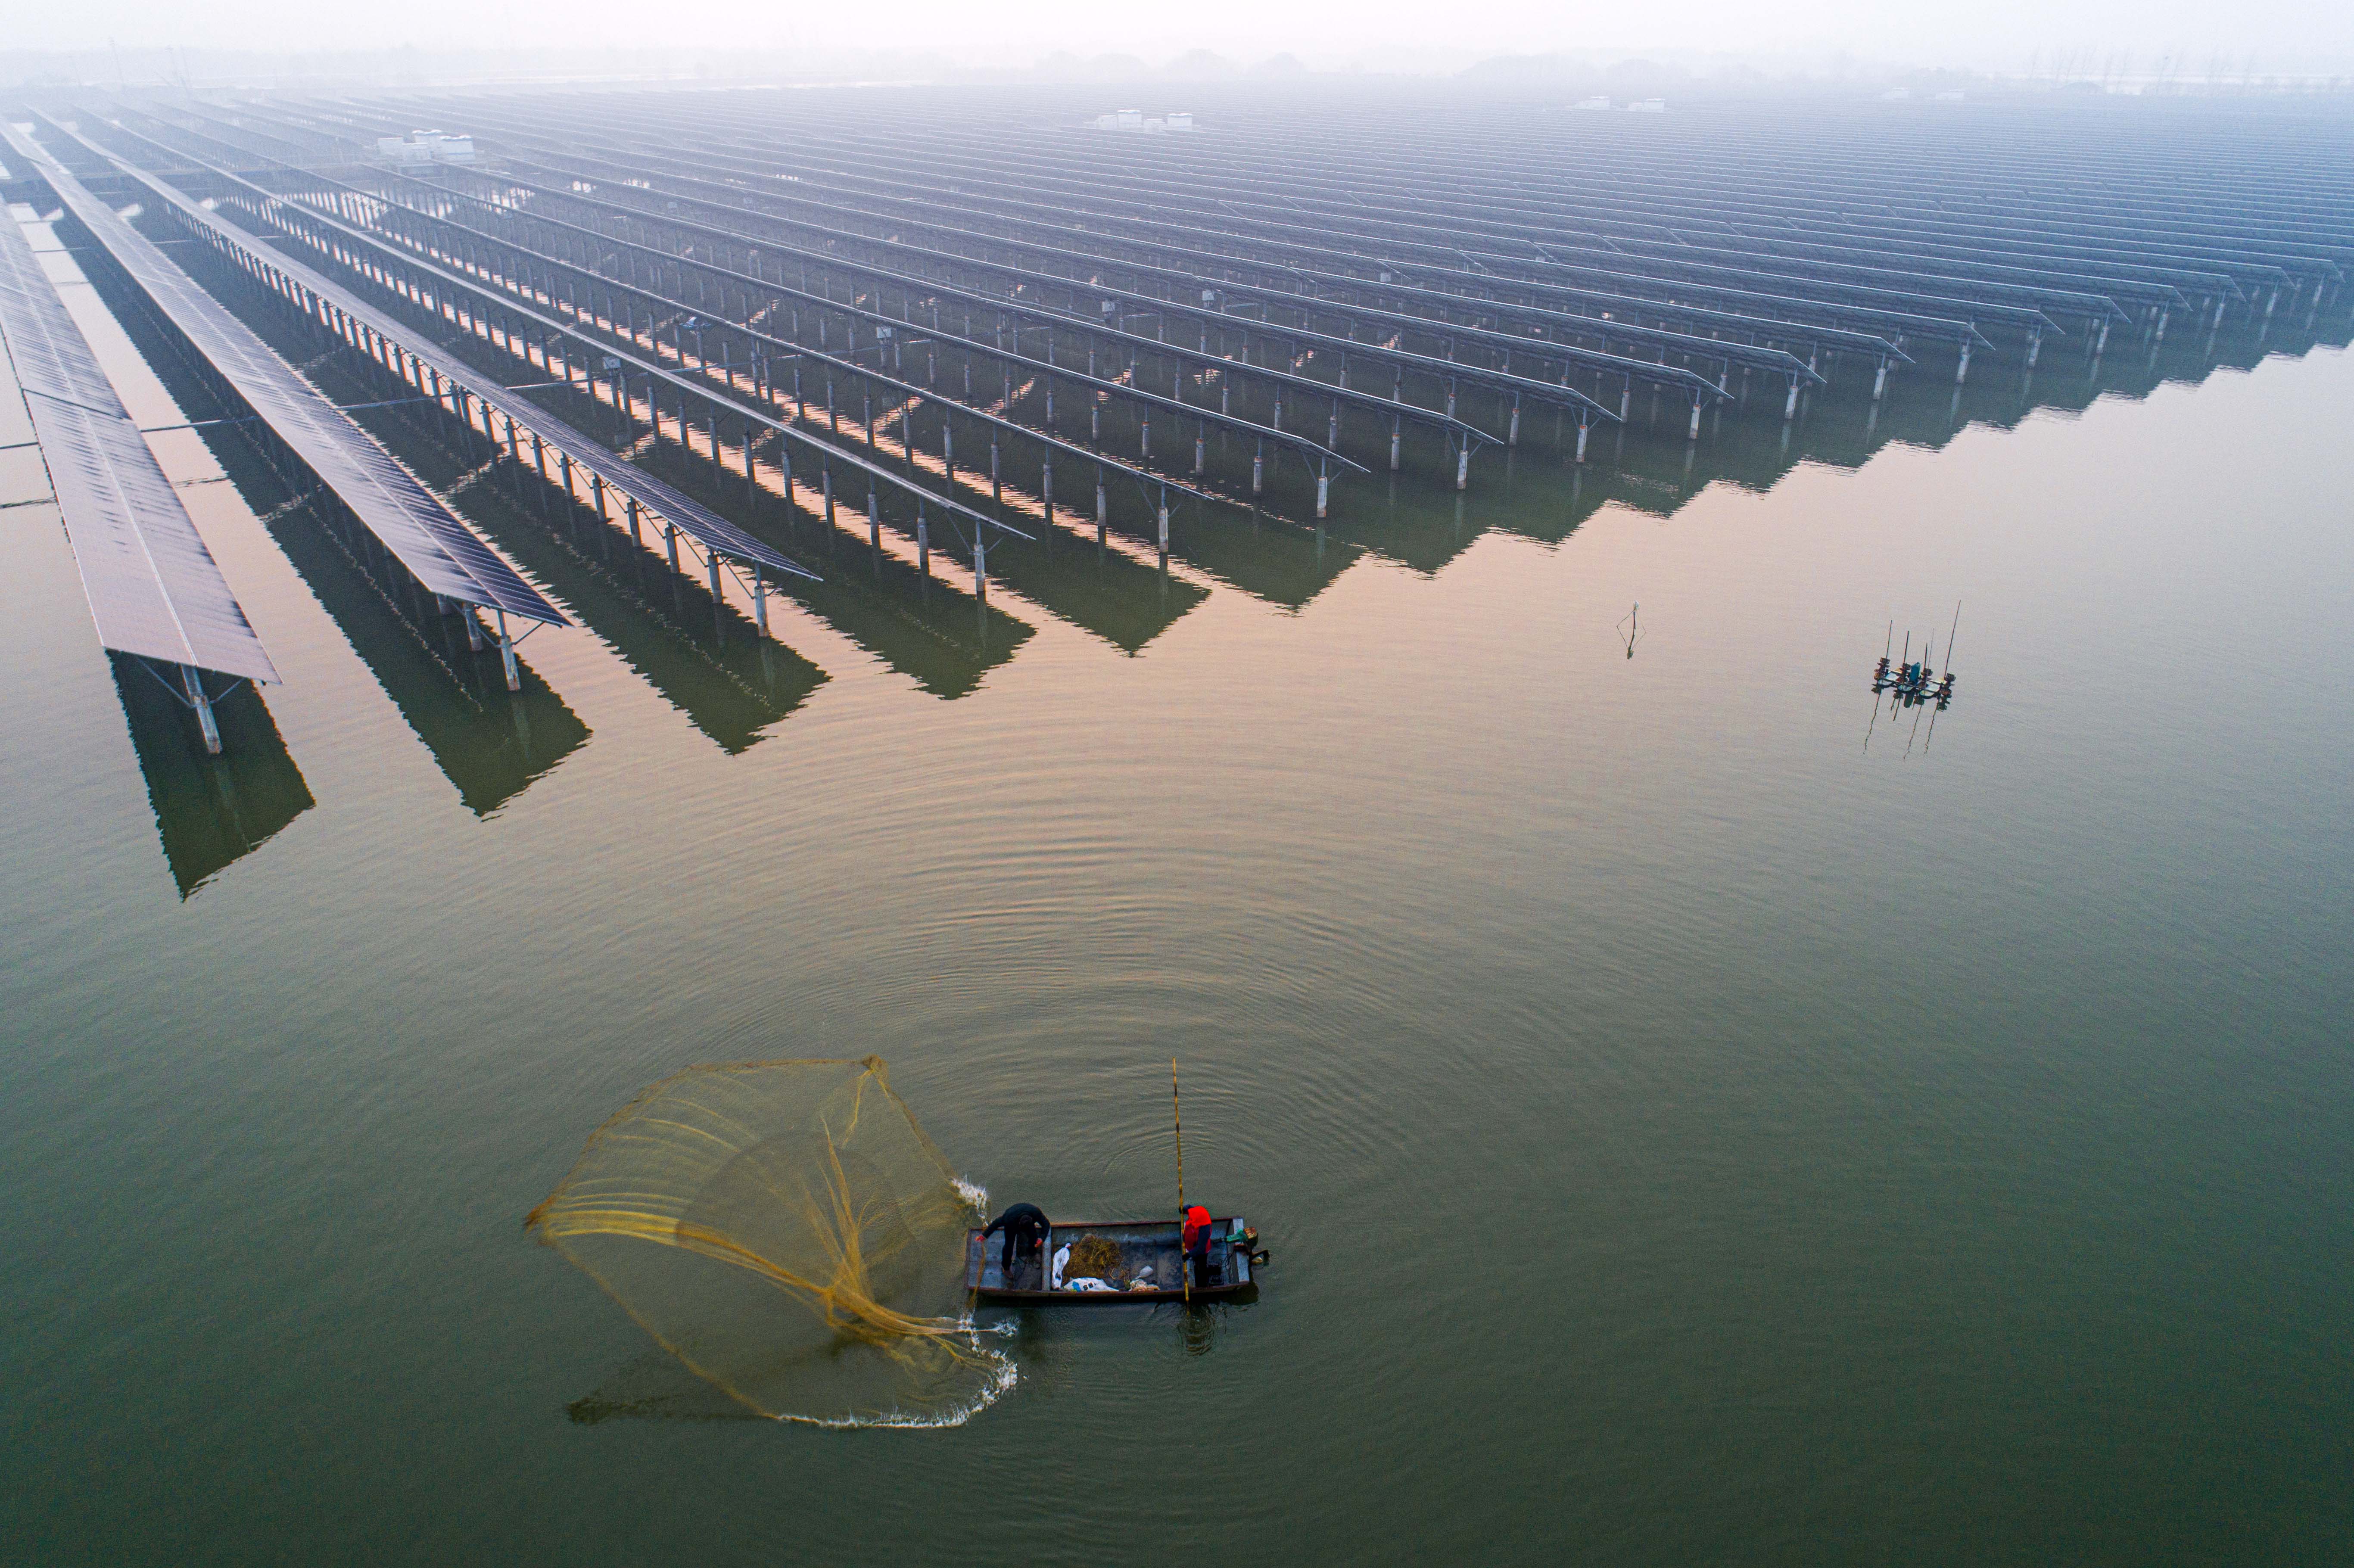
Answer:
[965, 1215, 1267, 1307]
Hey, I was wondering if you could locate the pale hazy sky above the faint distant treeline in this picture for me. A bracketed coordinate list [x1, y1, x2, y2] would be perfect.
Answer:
[18, 0, 2354, 73]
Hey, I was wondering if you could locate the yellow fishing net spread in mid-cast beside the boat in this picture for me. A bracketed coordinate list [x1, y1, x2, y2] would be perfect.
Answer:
[525, 1057, 1012, 1425]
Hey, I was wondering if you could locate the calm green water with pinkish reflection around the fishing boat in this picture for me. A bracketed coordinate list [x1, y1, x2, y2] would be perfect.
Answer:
[0, 211, 2354, 1563]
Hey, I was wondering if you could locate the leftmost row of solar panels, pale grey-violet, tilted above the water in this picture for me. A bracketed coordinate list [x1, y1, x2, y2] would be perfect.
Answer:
[0, 195, 278, 681]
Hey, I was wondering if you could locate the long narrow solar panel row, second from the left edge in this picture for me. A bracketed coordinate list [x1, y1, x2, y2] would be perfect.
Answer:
[0, 125, 570, 626]
